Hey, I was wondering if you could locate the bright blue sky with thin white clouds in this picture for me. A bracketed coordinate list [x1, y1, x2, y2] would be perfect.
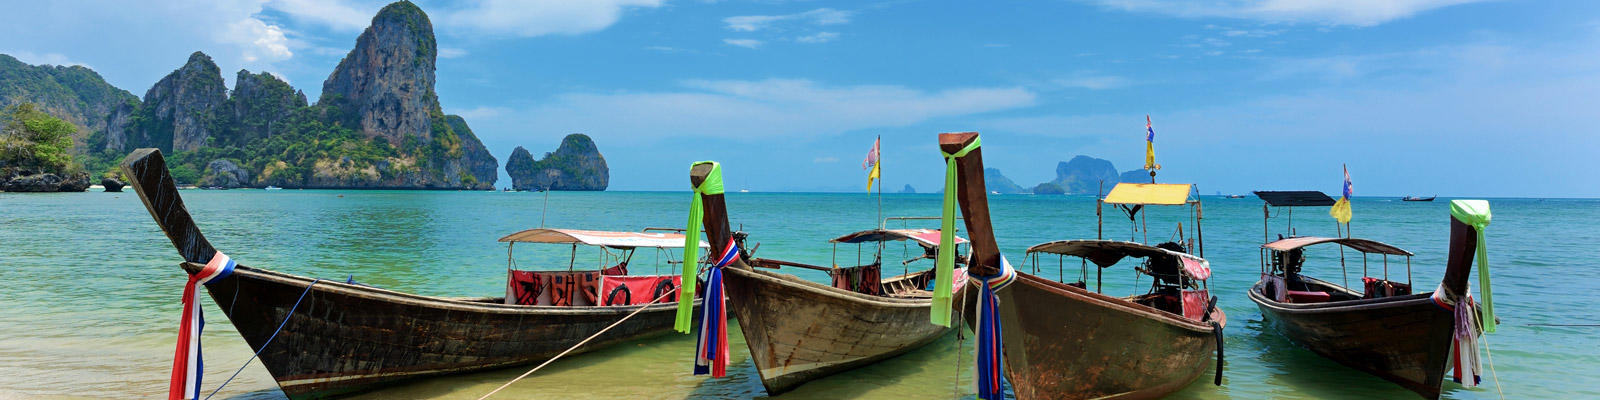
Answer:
[0, 0, 1600, 197]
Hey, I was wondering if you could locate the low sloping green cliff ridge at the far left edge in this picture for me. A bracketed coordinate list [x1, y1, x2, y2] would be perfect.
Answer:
[0, 54, 139, 150]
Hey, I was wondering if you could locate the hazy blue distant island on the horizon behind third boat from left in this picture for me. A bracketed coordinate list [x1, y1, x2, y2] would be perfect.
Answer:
[984, 155, 1149, 195]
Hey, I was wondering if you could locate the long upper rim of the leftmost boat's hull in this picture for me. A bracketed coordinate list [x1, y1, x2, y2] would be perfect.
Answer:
[179, 262, 701, 315]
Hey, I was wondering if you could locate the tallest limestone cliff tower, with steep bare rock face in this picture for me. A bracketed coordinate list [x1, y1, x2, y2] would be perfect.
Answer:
[318, 2, 440, 144]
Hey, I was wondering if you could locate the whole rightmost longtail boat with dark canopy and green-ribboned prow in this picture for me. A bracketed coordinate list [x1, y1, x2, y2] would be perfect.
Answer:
[1250, 192, 1488, 398]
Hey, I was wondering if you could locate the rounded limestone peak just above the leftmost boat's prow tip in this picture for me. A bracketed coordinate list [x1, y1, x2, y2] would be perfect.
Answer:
[136, 51, 227, 152]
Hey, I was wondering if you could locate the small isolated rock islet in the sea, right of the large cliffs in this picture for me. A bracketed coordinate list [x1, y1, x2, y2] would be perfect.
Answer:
[506, 133, 611, 190]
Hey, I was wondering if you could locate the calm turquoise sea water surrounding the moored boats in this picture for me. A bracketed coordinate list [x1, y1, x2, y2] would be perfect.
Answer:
[0, 190, 1600, 398]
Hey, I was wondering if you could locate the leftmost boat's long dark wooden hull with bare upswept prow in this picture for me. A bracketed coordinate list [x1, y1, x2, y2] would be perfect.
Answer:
[122, 149, 699, 398]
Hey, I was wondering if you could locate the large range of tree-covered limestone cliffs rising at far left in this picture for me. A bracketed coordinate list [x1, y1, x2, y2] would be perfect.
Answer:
[0, 2, 499, 189]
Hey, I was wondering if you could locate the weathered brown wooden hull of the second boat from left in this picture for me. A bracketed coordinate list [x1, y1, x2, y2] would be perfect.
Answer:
[723, 267, 950, 395]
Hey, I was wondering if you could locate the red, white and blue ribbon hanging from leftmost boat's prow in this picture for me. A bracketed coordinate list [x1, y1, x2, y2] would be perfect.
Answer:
[166, 251, 235, 400]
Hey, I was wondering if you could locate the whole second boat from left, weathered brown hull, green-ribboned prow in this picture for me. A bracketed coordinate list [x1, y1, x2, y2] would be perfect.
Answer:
[690, 163, 950, 395]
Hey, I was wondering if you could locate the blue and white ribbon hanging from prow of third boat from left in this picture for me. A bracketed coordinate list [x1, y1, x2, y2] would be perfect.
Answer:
[968, 256, 1016, 400]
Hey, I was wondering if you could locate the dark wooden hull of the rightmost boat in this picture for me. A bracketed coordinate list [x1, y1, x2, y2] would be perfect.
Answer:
[1250, 282, 1456, 398]
